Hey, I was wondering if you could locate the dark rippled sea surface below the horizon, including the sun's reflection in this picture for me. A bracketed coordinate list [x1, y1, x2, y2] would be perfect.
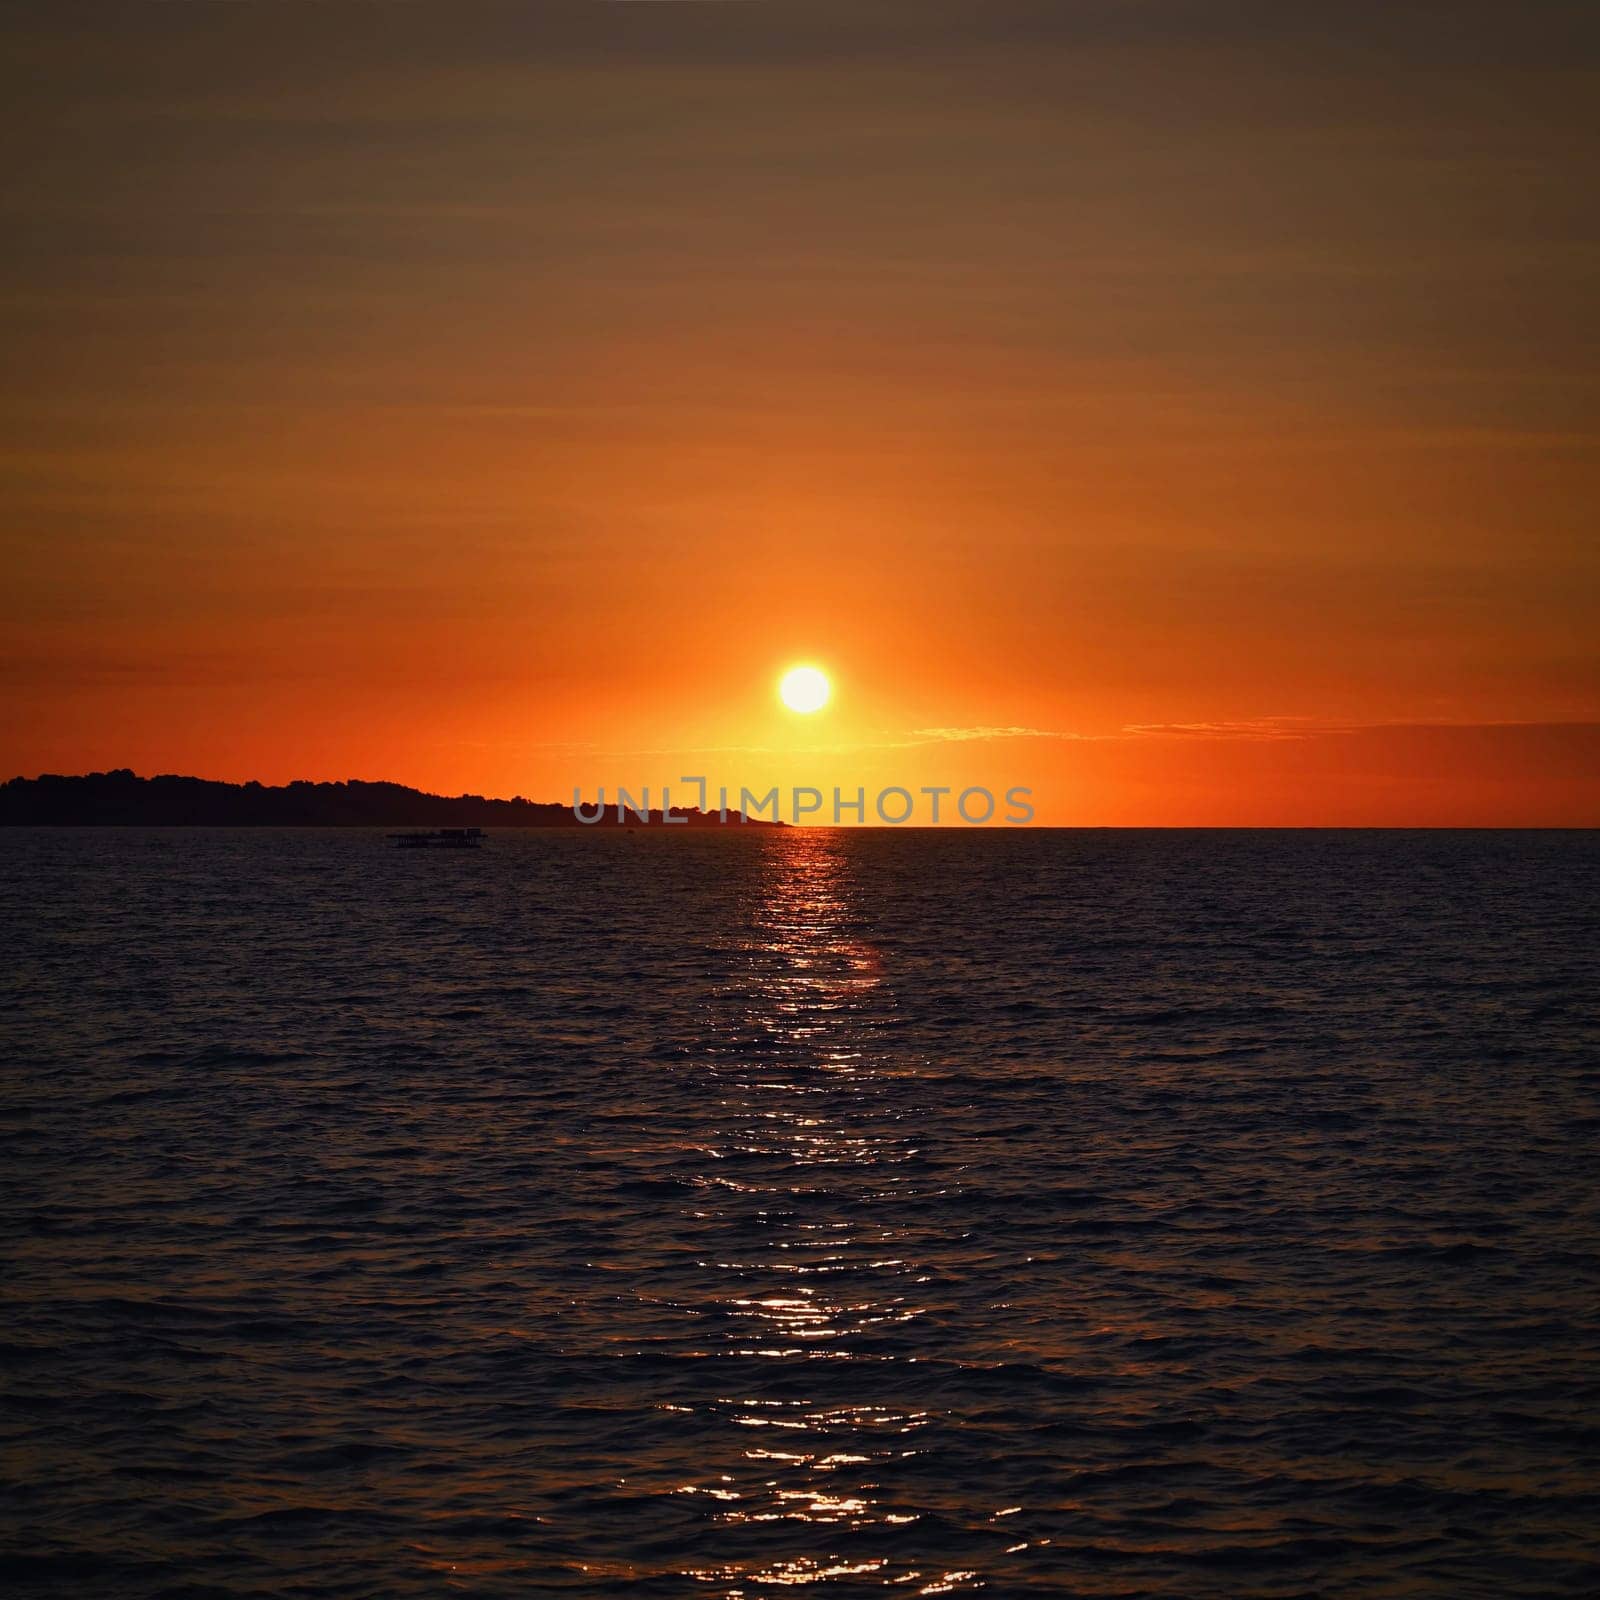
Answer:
[0, 829, 1600, 1600]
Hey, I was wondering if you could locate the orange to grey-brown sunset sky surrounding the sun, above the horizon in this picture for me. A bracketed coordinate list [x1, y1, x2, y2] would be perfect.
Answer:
[0, 0, 1600, 824]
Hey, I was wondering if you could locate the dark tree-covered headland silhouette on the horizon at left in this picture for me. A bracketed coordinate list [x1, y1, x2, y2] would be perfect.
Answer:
[0, 768, 782, 827]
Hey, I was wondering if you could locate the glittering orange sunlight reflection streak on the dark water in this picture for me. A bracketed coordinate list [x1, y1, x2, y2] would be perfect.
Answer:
[678, 830, 1011, 1600]
